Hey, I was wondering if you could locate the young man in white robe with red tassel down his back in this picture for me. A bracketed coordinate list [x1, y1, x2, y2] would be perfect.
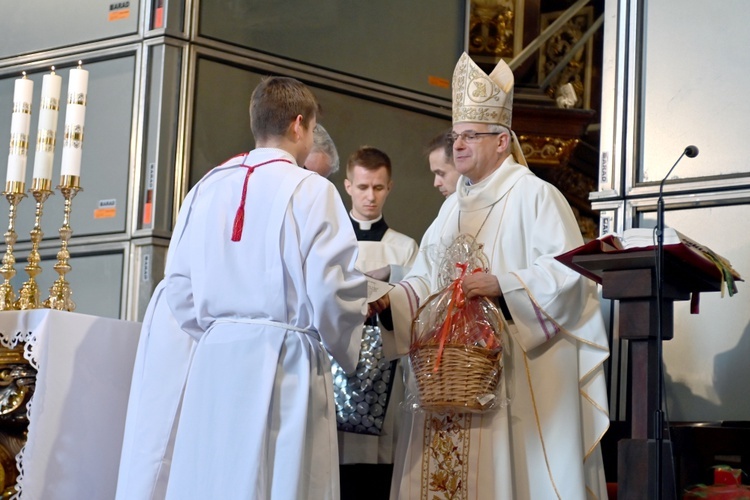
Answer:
[156, 78, 367, 500]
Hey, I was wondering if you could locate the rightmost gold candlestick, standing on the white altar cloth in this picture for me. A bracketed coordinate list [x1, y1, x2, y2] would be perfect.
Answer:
[44, 175, 82, 312]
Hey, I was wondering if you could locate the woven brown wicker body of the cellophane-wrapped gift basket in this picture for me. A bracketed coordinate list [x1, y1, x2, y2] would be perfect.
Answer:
[409, 344, 502, 412]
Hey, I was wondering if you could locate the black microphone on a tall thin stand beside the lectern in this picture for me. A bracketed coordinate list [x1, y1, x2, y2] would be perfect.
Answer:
[652, 145, 698, 500]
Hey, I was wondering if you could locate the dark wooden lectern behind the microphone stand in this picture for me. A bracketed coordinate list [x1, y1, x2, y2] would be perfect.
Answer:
[558, 247, 721, 500]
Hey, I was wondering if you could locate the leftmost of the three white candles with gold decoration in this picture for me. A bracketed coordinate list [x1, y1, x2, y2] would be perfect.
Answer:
[5, 72, 34, 187]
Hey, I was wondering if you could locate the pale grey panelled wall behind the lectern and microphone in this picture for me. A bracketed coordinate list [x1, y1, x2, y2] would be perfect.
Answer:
[591, 0, 750, 421]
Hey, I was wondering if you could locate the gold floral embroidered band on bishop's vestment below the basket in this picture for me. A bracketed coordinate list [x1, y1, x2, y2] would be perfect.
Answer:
[420, 413, 472, 500]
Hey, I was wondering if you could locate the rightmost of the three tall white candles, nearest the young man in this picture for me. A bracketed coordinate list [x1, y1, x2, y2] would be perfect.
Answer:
[60, 61, 89, 177]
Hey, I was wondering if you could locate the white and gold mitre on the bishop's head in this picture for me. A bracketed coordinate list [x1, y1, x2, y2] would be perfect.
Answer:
[453, 52, 528, 166]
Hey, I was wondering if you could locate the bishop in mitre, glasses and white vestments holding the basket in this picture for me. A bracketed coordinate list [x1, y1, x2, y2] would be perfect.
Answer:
[378, 54, 609, 500]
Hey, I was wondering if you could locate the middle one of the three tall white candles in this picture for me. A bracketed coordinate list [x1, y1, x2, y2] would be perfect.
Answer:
[33, 66, 62, 180]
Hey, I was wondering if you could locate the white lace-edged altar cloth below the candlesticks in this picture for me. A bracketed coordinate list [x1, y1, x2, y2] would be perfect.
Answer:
[0, 309, 140, 500]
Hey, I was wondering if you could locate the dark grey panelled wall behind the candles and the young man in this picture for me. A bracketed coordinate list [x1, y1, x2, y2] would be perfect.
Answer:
[0, 0, 467, 320]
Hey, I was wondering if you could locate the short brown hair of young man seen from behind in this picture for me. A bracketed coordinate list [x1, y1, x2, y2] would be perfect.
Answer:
[250, 76, 320, 141]
